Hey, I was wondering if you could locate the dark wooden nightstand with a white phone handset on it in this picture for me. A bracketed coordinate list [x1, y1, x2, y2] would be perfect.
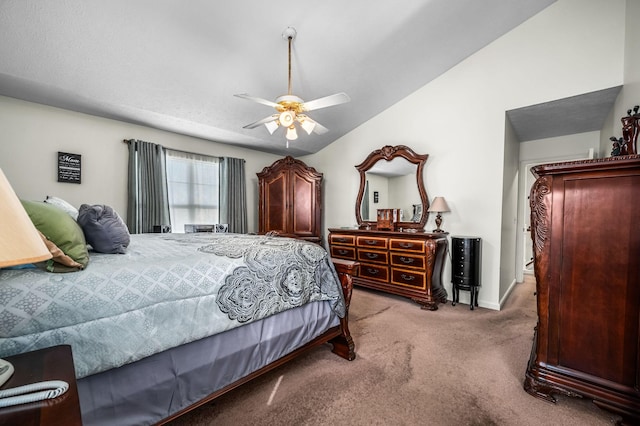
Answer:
[0, 345, 82, 426]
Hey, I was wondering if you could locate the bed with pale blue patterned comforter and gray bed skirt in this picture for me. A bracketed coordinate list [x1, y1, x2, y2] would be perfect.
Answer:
[0, 233, 357, 425]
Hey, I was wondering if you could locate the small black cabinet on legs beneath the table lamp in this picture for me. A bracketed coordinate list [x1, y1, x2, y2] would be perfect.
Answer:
[451, 236, 482, 310]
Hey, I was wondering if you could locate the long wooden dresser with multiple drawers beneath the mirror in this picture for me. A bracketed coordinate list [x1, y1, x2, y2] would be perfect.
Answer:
[329, 228, 447, 310]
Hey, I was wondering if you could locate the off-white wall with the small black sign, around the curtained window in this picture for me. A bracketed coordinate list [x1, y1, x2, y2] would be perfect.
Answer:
[0, 96, 280, 232]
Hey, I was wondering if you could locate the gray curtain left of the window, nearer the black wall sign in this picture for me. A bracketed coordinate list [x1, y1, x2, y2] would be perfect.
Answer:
[127, 139, 170, 234]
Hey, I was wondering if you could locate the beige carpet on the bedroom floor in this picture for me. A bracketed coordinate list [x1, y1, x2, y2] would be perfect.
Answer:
[171, 277, 617, 426]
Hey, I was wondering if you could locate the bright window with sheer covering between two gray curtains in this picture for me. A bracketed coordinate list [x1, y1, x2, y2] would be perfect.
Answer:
[166, 149, 219, 232]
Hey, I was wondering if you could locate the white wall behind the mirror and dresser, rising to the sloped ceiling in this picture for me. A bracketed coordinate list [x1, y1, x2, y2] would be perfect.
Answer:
[305, 0, 625, 309]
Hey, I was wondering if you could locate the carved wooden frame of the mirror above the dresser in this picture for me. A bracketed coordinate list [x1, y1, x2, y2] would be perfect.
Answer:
[356, 145, 429, 230]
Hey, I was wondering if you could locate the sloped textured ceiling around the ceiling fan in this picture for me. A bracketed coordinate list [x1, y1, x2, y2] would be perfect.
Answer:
[0, 0, 554, 156]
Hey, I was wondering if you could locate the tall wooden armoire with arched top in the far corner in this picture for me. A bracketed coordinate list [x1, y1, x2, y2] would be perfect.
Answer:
[257, 156, 322, 244]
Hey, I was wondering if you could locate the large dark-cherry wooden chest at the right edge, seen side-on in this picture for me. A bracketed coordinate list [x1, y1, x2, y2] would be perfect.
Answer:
[524, 155, 640, 425]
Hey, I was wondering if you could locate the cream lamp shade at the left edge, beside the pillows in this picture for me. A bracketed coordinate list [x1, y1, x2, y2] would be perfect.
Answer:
[0, 169, 51, 268]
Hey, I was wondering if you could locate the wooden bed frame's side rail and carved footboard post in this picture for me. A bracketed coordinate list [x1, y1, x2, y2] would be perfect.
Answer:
[157, 259, 359, 425]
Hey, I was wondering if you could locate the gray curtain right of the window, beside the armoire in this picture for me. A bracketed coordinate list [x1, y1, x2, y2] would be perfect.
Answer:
[220, 157, 248, 234]
